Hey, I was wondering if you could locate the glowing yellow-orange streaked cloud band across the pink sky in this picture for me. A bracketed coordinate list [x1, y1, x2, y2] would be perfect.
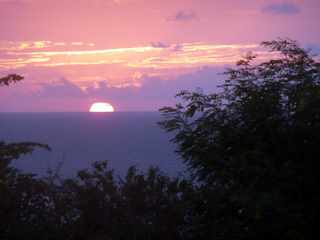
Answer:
[0, 41, 258, 69]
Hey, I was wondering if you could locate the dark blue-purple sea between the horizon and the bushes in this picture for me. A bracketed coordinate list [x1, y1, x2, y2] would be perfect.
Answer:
[0, 112, 183, 176]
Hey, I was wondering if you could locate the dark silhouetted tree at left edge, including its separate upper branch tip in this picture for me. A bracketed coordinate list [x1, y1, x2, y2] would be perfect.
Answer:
[0, 74, 50, 239]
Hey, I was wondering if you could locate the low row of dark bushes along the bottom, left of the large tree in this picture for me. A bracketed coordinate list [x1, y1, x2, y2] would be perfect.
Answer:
[0, 159, 195, 240]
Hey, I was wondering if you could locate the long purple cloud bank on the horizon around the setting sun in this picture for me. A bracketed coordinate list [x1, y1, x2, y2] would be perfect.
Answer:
[0, 67, 223, 112]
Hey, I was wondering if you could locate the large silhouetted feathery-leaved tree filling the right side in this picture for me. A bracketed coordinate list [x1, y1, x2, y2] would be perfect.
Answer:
[160, 39, 320, 239]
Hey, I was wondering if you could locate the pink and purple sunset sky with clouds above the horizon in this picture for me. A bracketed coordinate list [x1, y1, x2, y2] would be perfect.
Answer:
[0, 0, 320, 112]
